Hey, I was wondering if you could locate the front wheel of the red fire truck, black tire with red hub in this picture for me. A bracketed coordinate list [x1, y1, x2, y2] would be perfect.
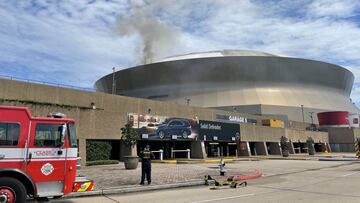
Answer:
[0, 177, 26, 203]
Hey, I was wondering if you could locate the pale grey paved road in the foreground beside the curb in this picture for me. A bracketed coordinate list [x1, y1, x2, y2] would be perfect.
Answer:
[36, 160, 360, 203]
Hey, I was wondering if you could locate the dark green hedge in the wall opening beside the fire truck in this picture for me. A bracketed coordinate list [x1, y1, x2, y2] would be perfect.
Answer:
[86, 140, 112, 161]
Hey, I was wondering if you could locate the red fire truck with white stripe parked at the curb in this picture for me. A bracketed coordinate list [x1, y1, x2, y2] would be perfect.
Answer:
[0, 106, 94, 203]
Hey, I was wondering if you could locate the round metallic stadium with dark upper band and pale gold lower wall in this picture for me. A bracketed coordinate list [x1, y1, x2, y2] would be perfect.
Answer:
[95, 50, 358, 122]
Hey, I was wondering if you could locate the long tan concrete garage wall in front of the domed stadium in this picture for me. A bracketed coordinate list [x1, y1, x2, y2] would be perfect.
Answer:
[0, 79, 334, 165]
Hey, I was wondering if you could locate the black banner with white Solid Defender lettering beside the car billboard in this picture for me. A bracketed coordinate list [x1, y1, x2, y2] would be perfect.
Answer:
[199, 120, 240, 141]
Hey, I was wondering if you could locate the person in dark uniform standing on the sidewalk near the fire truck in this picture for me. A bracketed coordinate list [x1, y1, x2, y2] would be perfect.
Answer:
[139, 145, 155, 185]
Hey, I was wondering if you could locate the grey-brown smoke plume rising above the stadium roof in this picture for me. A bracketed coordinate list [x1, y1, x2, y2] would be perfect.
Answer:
[116, 0, 179, 64]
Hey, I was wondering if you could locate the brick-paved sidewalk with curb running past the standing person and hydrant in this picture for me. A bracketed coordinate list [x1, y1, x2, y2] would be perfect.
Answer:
[68, 153, 354, 198]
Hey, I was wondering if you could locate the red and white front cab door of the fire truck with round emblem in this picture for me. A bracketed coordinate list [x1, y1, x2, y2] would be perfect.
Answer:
[27, 122, 67, 197]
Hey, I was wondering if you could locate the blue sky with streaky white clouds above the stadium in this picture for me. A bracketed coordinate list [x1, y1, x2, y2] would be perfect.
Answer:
[0, 0, 360, 104]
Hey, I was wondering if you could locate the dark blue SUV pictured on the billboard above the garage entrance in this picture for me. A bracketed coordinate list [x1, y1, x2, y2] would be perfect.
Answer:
[156, 119, 191, 139]
